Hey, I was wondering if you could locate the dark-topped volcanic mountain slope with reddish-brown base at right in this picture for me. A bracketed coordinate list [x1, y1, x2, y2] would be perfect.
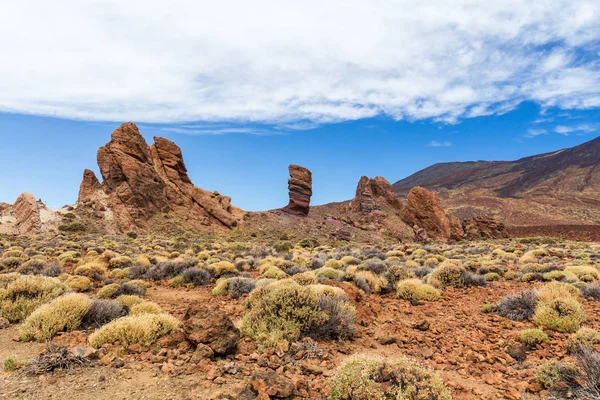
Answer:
[393, 137, 600, 229]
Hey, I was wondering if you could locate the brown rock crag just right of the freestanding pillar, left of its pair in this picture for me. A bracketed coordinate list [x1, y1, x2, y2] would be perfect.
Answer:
[352, 176, 401, 215]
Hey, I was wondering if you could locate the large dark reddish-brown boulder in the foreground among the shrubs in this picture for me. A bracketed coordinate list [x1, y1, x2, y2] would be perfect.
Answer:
[183, 304, 240, 355]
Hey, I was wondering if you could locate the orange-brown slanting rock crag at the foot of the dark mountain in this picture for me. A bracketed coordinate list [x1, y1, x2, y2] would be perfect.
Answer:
[402, 186, 464, 240]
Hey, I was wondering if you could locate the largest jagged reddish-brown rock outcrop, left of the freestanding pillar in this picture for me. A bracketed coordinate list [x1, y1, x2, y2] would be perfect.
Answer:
[78, 122, 243, 232]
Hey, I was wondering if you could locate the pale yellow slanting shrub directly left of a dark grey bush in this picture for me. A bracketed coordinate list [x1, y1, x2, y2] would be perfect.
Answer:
[19, 293, 92, 342]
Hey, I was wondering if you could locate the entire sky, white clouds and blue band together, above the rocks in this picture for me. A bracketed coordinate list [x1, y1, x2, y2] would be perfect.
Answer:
[0, 0, 600, 210]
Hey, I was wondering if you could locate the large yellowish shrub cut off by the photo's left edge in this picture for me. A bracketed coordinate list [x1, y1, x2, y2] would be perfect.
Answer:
[0, 275, 69, 322]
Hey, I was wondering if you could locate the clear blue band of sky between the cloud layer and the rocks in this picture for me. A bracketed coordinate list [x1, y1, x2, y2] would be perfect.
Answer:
[0, 103, 600, 210]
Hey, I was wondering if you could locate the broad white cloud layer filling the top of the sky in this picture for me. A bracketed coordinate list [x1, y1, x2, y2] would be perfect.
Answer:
[0, 0, 600, 126]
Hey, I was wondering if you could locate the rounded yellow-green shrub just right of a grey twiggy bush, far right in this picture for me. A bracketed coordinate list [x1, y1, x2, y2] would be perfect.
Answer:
[533, 297, 585, 332]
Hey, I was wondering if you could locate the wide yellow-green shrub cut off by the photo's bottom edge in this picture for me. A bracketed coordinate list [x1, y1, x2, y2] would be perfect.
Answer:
[329, 356, 452, 400]
